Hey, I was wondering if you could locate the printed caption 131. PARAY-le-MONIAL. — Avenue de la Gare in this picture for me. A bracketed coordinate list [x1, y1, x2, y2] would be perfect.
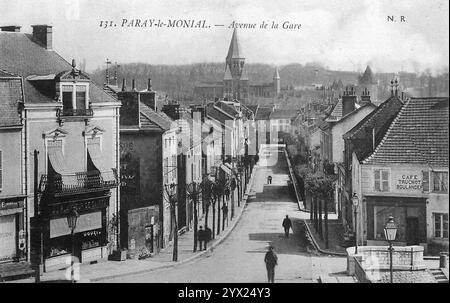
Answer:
[99, 18, 302, 30]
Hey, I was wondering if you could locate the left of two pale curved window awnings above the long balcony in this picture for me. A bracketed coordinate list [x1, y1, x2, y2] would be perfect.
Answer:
[47, 141, 78, 186]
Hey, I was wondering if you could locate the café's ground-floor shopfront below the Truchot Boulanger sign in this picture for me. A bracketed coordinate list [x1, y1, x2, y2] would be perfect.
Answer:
[365, 196, 427, 246]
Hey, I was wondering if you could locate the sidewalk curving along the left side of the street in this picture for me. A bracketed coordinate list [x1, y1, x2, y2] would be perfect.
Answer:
[7, 166, 257, 283]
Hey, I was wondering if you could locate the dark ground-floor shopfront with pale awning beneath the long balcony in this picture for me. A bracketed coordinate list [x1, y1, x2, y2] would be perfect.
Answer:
[43, 195, 109, 271]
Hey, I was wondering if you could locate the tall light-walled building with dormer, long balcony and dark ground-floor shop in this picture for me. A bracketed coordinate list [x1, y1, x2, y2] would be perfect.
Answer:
[0, 25, 120, 270]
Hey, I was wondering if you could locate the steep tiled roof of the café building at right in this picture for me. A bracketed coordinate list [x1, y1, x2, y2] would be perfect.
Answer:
[363, 97, 449, 166]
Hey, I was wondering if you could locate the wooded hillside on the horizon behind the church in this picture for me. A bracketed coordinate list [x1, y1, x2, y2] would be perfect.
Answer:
[91, 63, 449, 101]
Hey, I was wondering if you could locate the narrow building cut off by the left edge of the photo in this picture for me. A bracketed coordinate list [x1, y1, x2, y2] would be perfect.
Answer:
[0, 69, 29, 264]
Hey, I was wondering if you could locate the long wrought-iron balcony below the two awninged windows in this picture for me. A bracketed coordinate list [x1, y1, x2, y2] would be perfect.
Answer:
[39, 169, 118, 196]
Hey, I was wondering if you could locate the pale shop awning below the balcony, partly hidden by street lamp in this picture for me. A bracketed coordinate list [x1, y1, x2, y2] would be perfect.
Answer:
[50, 211, 102, 238]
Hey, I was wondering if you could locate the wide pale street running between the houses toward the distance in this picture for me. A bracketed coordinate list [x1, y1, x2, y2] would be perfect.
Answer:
[106, 148, 346, 283]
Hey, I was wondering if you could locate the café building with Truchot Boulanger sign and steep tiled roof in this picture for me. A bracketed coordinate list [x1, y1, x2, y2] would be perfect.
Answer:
[352, 98, 449, 253]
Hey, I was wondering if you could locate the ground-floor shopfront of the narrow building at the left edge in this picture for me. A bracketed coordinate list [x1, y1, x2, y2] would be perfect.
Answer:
[0, 196, 27, 263]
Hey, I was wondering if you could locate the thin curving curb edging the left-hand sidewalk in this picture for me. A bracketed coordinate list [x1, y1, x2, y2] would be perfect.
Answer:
[89, 169, 254, 283]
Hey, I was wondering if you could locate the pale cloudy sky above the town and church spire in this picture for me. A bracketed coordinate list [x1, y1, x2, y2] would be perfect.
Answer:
[0, 0, 449, 73]
